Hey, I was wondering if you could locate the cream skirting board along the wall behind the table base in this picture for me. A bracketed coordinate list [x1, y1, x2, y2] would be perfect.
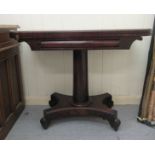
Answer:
[25, 96, 141, 105]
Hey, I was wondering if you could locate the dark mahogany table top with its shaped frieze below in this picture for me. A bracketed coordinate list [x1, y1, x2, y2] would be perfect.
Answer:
[11, 29, 151, 50]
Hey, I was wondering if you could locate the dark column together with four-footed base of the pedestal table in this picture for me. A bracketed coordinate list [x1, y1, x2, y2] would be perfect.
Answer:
[40, 50, 120, 130]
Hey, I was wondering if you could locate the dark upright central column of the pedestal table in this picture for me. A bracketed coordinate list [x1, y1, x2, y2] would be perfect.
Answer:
[72, 50, 89, 106]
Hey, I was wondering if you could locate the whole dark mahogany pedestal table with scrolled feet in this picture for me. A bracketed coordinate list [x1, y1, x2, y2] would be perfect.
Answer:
[11, 29, 151, 131]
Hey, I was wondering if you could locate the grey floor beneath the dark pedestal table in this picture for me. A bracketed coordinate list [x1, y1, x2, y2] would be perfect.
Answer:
[6, 105, 155, 140]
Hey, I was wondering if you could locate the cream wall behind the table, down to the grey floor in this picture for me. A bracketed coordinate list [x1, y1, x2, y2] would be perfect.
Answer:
[0, 14, 153, 104]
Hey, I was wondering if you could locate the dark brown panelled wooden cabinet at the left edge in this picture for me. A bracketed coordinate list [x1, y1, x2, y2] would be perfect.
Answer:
[0, 26, 24, 139]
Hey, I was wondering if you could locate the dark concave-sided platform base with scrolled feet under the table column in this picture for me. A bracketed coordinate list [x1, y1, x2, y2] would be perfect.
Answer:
[40, 93, 120, 131]
